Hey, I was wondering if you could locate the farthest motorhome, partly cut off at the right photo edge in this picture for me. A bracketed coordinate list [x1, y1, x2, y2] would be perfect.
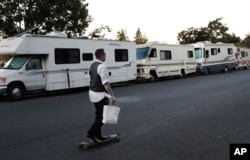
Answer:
[236, 47, 250, 69]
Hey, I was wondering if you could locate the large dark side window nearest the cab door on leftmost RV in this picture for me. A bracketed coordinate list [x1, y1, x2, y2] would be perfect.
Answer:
[55, 48, 80, 64]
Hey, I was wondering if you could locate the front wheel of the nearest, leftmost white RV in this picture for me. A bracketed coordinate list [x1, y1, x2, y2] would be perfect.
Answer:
[7, 84, 24, 101]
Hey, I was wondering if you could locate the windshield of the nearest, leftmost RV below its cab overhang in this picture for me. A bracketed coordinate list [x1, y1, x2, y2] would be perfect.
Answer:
[3, 56, 29, 70]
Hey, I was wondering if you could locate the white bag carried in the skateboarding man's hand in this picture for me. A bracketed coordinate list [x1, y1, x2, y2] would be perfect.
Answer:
[102, 105, 120, 124]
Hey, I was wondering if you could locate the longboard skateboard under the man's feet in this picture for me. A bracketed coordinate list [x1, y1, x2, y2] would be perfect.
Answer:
[78, 133, 120, 149]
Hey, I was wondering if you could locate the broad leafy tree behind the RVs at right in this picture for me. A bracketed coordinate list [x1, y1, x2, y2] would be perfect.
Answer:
[177, 18, 241, 44]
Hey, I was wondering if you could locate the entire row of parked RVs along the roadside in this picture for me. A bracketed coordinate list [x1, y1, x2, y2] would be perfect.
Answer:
[0, 34, 250, 100]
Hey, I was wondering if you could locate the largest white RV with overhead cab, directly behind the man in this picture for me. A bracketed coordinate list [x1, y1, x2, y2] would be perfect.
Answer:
[0, 34, 137, 100]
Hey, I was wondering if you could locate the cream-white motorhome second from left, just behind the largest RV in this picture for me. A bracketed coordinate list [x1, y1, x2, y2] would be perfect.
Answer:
[136, 42, 196, 81]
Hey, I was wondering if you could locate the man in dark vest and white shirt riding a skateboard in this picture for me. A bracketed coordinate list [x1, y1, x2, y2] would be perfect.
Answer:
[87, 49, 116, 143]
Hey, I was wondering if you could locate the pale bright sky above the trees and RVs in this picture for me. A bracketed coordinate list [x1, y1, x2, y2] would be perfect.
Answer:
[85, 0, 250, 44]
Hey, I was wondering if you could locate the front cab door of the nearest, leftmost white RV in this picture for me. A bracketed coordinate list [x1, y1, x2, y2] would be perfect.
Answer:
[24, 56, 46, 91]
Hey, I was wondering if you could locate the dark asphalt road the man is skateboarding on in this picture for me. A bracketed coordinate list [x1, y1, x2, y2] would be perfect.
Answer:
[0, 70, 250, 160]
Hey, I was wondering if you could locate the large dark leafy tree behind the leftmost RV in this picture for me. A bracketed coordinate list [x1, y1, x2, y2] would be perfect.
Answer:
[0, 0, 92, 36]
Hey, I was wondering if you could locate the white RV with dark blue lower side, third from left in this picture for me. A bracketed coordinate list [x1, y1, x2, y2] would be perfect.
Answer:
[193, 41, 236, 74]
